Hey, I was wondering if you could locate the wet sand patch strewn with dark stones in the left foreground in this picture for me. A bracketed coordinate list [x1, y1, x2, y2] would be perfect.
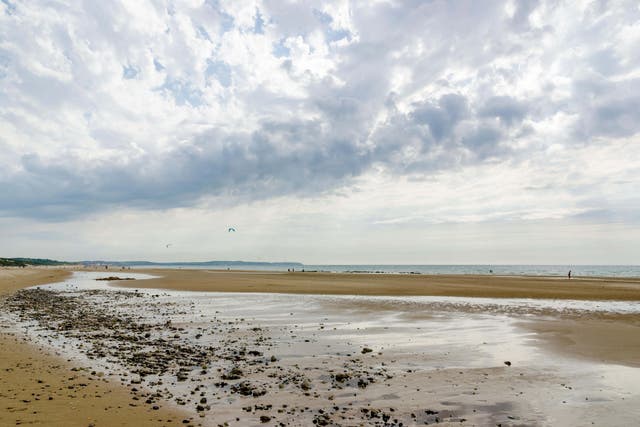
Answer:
[4, 288, 536, 426]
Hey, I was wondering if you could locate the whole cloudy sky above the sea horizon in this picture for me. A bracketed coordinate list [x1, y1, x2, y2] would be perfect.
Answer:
[0, 0, 640, 264]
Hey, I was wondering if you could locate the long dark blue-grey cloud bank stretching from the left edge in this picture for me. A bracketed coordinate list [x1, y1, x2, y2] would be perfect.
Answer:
[0, 89, 516, 219]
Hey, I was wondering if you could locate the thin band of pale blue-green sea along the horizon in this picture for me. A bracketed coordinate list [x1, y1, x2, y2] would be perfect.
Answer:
[124, 262, 640, 277]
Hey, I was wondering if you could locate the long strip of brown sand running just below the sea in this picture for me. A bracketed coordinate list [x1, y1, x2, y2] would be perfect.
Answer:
[121, 269, 640, 301]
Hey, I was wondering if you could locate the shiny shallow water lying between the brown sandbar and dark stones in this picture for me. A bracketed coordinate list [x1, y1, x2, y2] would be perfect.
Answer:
[8, 272, 640, 425]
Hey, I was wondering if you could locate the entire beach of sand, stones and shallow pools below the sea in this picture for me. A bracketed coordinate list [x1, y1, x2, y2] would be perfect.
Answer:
[0, 269, 640, 426]
